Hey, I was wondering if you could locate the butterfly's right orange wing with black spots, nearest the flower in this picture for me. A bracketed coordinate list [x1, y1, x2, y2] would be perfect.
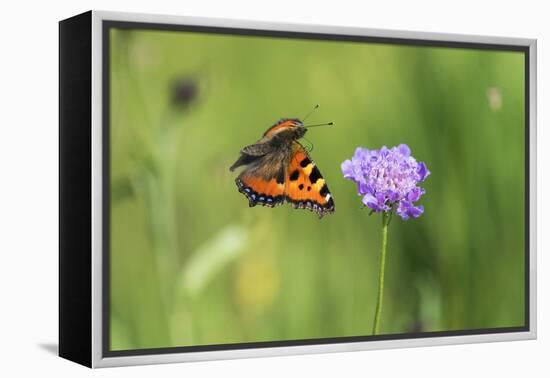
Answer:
[284, 142, 334, 218]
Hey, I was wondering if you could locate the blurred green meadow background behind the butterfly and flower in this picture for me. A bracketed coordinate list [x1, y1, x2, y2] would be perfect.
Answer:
[110, 29, 525, 350]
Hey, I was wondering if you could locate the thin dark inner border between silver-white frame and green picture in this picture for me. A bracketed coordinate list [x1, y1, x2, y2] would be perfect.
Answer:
[101, 20, 531, 358]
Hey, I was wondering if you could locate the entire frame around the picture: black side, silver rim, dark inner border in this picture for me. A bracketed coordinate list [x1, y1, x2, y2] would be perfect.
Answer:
[59, 11, 537, 368]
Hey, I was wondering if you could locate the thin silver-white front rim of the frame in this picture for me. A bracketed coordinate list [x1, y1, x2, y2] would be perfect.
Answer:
[92, 11, 537, 367]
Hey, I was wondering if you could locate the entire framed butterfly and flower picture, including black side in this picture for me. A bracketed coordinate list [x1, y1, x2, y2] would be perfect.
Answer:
[59, 11, 536, 367]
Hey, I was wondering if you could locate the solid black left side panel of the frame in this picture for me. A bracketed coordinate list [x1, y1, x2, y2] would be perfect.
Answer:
[58, 11, 92, 367]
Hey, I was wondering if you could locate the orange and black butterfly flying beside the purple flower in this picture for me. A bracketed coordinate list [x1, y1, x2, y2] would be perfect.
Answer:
[229, 118, 334, 218]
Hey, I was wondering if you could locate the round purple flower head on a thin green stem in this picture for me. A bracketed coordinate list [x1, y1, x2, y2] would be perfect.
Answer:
[342, 144, 430, 220]
